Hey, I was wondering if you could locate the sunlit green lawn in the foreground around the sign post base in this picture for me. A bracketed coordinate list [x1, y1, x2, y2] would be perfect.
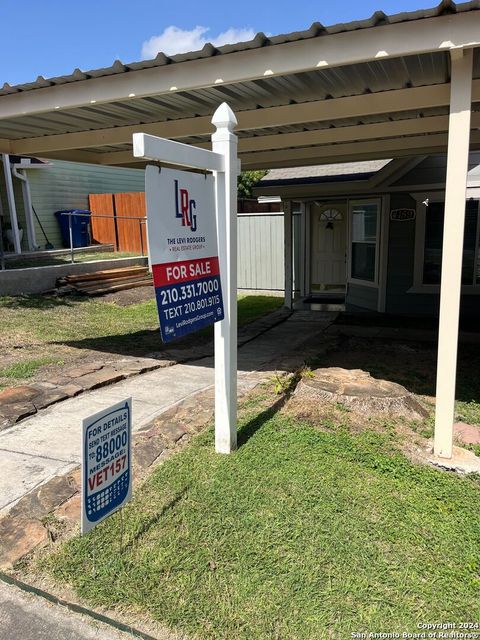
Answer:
[42, 391, 480, 640]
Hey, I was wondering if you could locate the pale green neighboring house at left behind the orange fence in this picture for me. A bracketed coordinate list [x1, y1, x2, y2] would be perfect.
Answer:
[0, 156, 145, 252]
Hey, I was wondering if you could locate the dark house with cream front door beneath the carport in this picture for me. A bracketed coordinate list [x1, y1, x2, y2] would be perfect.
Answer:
[255, 153, 480, 315]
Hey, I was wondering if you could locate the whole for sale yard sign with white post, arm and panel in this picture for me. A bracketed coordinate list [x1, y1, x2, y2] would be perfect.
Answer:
[133, 102, 240, 453]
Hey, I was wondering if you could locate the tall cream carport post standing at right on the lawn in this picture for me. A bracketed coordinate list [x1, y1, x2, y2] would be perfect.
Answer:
[434, 49, 473, 458]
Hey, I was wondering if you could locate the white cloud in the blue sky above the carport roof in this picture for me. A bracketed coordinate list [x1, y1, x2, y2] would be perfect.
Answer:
[142, 25, 255, 60]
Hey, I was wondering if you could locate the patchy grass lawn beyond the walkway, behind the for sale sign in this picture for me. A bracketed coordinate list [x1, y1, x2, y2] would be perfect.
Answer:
[0, 294, 283, 387]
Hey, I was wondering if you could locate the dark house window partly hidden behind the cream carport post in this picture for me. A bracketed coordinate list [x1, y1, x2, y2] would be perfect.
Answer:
[422, 200, 480, 285]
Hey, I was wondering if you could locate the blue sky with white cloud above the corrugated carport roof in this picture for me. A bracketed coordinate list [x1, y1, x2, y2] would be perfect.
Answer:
[0, 0, 438, 86]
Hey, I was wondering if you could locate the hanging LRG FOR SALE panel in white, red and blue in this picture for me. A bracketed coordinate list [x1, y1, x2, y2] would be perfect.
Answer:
[145, 166, 224, 342]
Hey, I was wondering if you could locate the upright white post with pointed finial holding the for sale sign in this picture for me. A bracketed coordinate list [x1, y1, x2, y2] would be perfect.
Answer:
[212, 102, 238, 453]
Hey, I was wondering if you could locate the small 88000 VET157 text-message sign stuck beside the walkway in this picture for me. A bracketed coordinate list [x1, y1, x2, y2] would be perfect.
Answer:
[81, 398, 132, 534]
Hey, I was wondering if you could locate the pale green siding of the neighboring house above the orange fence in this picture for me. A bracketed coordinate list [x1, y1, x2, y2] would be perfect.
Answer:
[25, 160, 145, 248]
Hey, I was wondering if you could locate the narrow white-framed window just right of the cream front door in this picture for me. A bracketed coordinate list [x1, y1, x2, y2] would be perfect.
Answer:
[350, 200, 380, 282]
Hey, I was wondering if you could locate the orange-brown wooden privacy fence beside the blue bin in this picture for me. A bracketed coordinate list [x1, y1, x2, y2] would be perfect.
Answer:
[88, 192, 147, 254]
